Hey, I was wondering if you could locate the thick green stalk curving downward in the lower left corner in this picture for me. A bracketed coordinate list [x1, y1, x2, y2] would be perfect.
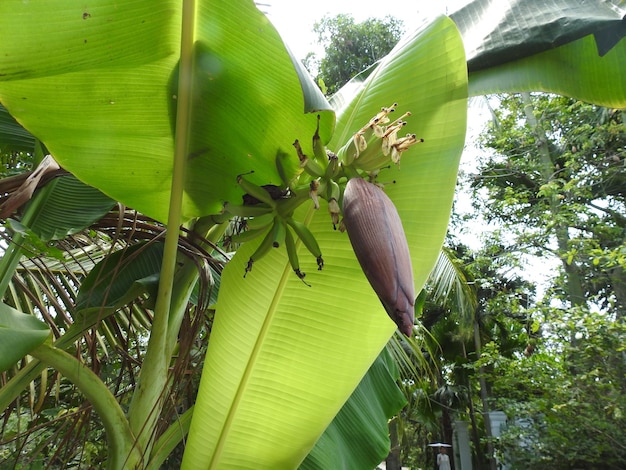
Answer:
[31, 343, 142, 470]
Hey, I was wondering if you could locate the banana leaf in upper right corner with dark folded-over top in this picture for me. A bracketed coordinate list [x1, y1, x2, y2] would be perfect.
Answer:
[451, 0, 626, 103]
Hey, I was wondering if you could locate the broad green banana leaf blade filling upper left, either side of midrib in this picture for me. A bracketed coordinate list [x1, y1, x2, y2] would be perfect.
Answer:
[0, 0, 334, 221]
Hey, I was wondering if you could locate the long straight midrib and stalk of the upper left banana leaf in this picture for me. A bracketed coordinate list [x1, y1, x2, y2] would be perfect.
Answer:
[129, 0, 196, 455]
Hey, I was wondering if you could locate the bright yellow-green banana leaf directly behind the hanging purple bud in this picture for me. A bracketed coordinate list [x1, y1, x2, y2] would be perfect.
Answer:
[183, 18, 467, 469]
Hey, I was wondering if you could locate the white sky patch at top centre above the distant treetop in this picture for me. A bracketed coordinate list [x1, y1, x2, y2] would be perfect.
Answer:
[257, 0, 467, 59]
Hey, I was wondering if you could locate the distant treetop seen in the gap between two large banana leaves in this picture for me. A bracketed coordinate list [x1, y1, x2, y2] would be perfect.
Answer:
[305, 14, 403, 95]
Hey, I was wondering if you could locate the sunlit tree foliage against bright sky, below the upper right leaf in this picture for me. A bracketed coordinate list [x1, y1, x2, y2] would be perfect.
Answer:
[472, 95, 626, 315]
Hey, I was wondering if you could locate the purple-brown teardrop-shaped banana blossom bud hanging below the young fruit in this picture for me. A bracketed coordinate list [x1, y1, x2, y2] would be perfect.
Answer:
[343, 178, 415, 336]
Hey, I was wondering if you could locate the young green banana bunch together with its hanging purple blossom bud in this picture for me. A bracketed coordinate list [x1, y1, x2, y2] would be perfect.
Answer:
[217, 103, 423, 334]
